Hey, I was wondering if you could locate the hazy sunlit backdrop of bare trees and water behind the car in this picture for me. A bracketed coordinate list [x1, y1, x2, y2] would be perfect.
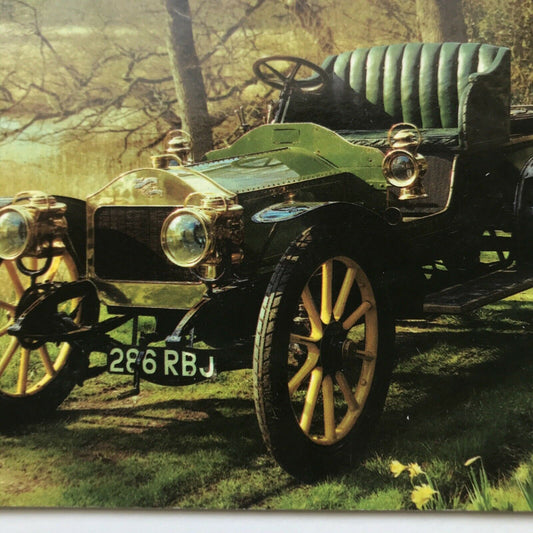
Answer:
[0, 0, 533, 200]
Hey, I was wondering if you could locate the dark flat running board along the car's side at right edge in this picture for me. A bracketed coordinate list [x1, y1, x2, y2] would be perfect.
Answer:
[424, 269, 533, 315]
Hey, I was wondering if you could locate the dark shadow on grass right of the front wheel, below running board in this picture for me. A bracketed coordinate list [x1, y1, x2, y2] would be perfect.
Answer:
[375, 301, 533, 486]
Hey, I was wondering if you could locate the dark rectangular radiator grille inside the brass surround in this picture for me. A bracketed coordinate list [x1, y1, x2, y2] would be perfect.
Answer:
[94, 206, 198, 281]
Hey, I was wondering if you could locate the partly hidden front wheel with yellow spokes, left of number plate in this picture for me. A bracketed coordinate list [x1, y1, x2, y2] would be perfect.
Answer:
[0, 252, 89, 426]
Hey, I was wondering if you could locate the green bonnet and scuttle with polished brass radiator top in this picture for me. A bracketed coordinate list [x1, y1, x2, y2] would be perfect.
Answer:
[87, 124, 385, 210]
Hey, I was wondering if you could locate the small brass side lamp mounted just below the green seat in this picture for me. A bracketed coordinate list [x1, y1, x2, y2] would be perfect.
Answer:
[382, 122, 427, 200]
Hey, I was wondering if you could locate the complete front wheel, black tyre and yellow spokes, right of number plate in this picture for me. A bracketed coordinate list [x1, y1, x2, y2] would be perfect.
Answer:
[254, 228, 394, 480]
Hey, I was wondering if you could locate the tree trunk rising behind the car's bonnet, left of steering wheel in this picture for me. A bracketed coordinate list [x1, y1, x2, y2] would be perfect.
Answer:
[165, 0, 213, 161]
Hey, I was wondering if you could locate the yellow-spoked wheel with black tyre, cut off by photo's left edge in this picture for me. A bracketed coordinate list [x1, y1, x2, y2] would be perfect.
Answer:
[0, 252, 82, 423]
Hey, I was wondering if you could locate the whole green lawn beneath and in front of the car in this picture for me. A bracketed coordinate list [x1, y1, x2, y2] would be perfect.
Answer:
[0, 291, 533, 511]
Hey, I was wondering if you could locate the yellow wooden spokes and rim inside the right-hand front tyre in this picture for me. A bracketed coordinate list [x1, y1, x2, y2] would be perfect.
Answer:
[288, 256, 378, 446]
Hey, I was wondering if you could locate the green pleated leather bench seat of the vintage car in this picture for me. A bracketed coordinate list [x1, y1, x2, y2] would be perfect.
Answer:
[289, 43, 510, 148]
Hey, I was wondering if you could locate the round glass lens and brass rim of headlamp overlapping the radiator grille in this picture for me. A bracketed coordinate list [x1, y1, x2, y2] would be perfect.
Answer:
[161, 208, 213, 268]
